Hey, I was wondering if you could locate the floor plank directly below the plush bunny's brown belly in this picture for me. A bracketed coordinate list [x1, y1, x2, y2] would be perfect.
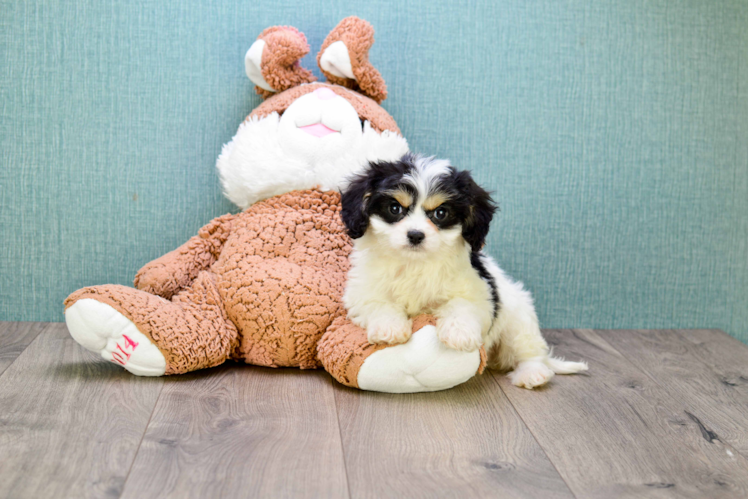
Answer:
[123, 364, 348, 498]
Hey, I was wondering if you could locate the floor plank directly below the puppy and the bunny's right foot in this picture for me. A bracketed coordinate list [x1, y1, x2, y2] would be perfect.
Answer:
[335, 375, 573, 498]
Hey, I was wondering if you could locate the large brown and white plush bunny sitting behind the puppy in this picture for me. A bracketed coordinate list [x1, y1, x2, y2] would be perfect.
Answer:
[65, 17, 485, 392]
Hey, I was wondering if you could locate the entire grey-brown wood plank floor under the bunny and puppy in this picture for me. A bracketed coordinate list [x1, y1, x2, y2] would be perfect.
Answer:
[0, 323, 748, 498]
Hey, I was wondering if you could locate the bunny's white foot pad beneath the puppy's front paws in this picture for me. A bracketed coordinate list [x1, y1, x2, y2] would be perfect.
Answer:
[358, 325, 480, 393]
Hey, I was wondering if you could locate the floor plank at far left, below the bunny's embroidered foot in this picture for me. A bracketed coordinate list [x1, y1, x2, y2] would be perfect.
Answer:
[0, 324, 163, 498]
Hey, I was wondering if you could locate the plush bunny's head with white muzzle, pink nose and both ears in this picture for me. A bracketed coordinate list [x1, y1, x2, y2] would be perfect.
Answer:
[217, 18, 408, 209]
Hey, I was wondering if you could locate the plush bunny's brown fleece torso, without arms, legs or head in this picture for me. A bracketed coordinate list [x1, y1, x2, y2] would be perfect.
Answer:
[212, 191, 351, 368]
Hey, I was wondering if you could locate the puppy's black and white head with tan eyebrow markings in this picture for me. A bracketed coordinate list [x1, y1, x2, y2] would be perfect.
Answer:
[342, 153, 496, 256]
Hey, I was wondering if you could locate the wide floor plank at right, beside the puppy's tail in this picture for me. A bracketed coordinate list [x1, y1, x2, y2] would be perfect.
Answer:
[499, 330, 748, 498]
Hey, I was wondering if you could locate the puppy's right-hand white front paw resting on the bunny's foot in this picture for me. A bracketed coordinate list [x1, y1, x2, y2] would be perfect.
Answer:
[436, 298, 491, 351]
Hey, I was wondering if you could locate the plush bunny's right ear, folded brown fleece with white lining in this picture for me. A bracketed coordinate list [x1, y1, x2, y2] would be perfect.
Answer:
[317, 16, 387, 103]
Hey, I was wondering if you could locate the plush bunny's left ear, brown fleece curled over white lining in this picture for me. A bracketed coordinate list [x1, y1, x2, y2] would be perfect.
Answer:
[244, 26, 317, 98]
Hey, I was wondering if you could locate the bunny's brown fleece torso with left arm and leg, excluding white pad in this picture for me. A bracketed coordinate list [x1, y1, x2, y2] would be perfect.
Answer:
[65, 190, 352, 380]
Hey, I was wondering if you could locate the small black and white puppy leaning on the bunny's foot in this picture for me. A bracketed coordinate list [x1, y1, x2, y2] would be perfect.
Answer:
[342, 153, 587, 388]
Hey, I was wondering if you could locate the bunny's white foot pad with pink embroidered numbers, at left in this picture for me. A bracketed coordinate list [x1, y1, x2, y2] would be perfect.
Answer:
[65, 299, 166, 377]
